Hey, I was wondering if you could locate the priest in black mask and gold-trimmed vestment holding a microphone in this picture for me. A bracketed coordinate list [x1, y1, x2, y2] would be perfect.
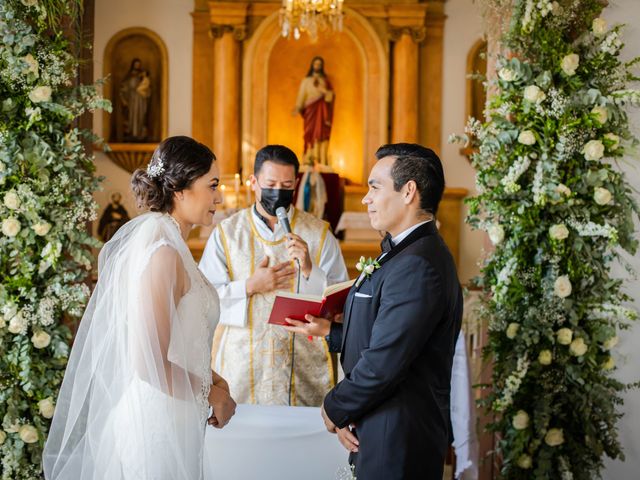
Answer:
[200, 145, 348, 406]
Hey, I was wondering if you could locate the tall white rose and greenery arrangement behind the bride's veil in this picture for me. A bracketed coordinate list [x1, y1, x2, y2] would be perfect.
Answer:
[0, 0, 110, 480]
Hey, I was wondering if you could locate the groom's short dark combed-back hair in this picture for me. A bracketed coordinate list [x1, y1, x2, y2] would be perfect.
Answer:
[376, 143, 444, 215]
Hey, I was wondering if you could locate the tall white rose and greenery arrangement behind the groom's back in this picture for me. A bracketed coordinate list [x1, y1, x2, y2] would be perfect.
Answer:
[452, 0, 640, 480]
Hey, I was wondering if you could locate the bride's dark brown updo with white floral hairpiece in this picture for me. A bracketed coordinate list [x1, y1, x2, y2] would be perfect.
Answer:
[131, 136, 216, 213]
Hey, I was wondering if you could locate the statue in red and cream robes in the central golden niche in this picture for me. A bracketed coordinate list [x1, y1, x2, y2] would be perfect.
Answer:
[294, 57, 335, 165]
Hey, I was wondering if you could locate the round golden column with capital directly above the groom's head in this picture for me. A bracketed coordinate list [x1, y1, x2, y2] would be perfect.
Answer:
[389, 4, 426, 143]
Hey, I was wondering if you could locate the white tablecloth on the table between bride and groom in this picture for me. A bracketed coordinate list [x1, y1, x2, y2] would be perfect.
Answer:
[204, 405, 348, 480]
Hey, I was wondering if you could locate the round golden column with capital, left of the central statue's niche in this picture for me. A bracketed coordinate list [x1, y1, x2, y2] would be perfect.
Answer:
[209, 2, 248, 175]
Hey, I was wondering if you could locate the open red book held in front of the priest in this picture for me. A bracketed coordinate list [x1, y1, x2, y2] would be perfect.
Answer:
[269, 279, 355, 325]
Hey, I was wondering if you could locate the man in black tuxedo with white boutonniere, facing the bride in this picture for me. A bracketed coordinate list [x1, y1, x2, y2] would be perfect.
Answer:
[287, 143, 462, 480]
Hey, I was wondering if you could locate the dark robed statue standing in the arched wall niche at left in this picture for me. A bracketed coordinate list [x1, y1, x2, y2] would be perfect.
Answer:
[119, 58, 151, 142]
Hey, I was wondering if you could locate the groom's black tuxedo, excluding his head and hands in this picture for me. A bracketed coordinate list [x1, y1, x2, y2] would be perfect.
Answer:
[324, 221, 462, 480]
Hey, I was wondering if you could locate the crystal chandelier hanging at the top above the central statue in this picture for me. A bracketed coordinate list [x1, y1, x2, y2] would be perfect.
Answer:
[280, 0, 344, 41]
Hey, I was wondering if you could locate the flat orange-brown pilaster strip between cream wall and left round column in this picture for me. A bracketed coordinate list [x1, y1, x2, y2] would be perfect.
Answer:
[191, 5, 213, 148]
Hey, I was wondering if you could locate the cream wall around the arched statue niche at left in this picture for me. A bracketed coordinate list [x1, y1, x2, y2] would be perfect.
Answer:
[93, 0, 194, 221]
